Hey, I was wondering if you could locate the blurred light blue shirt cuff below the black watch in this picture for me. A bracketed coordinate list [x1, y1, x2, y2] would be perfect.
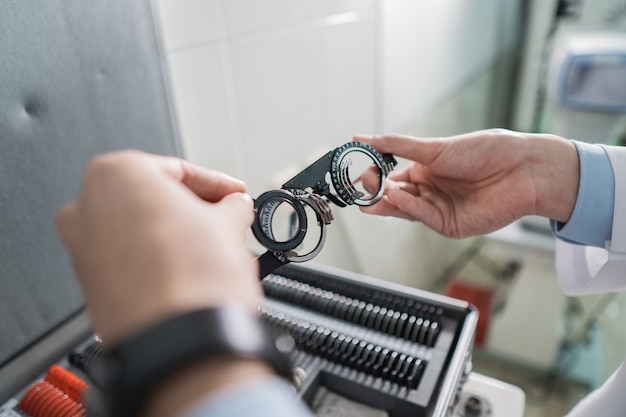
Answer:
[182, 378, 312, 417]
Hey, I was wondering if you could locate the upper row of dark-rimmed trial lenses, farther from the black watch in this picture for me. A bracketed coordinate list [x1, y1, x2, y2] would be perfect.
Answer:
[263, 275, 441, 347]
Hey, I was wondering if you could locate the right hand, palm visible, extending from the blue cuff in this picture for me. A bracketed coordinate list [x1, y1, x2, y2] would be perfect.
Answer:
[354, 129, 579, 238]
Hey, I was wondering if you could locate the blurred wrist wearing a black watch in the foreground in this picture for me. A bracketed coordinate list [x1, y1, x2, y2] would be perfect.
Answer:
[92, 305, 291, 417]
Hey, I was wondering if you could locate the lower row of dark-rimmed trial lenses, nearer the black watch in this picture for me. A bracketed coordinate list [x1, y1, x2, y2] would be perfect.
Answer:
[261, 306, 427, 389]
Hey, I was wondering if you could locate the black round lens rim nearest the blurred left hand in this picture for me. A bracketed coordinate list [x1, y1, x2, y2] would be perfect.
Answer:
[252, 190, 308, 252]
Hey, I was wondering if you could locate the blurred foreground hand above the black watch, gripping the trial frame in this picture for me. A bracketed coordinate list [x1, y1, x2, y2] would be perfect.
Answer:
[57, 151, 262, 343]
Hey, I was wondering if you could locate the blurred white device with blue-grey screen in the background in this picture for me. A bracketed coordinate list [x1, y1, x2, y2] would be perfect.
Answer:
[541, 31, 626, 144]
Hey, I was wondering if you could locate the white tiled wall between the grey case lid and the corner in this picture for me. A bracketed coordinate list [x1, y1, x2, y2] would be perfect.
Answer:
[159, 0, 375, 195]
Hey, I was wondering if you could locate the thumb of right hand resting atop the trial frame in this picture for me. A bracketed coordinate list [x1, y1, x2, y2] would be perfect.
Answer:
[353, 134, 443, 164]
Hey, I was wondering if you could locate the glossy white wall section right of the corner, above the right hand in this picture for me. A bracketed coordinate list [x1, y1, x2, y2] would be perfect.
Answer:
[379, 0, 520, 131]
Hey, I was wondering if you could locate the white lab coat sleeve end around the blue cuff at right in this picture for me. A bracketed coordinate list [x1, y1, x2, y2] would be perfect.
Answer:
[556, 146, 626, 295]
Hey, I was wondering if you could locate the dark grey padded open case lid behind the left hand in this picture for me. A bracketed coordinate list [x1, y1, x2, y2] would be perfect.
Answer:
[0, 0, 181, 374]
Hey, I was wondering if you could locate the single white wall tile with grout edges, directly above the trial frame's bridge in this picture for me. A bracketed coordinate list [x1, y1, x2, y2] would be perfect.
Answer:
[231, 28, 328, 194]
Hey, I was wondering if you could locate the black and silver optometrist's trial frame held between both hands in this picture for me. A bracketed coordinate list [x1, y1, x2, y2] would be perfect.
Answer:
[252, 142, 397, 278]
